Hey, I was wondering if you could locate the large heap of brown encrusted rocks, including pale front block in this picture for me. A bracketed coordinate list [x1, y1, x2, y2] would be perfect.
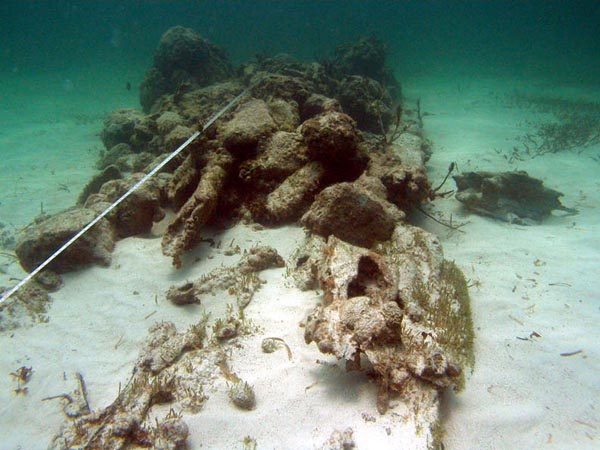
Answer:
[17, 27, 473, 450]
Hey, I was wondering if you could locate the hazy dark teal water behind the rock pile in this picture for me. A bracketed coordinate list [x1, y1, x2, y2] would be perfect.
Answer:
[0, 0, 600, 82]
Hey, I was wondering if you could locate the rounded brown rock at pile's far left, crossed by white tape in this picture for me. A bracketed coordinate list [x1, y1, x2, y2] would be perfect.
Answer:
[15, 208, 115, 273]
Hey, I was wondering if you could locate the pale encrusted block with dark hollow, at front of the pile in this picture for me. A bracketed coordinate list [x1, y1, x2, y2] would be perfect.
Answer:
[305, 225, 472, 410]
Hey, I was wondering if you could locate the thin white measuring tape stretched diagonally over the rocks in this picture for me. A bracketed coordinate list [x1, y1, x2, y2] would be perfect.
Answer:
[0, 86, 252, 304]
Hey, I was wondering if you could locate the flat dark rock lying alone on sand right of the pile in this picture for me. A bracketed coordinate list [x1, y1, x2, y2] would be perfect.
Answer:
[454, 171, 577, 225]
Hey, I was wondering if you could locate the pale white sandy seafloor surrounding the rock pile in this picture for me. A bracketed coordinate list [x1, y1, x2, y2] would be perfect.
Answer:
[0, 65, 600, 450]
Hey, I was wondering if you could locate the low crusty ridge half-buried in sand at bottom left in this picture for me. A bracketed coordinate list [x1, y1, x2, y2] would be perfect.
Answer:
[49, 319, 213, 450]
